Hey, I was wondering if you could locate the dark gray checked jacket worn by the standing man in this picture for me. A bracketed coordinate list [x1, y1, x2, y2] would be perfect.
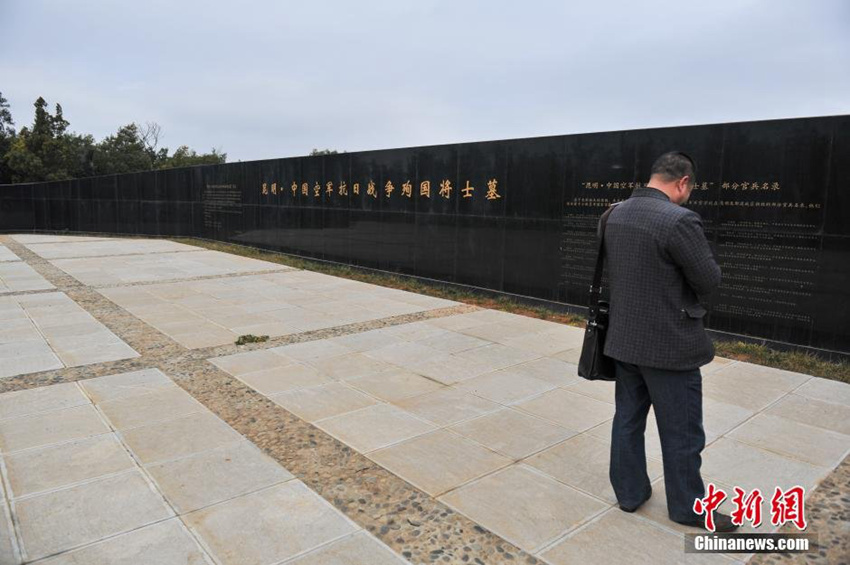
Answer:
[605, 187, 720, 370]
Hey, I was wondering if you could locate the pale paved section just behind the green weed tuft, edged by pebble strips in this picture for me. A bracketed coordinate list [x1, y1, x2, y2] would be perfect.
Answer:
[100, 270, 457, 349]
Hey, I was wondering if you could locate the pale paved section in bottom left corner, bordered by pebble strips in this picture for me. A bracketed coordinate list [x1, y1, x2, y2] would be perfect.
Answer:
[0, 369, 402, 565]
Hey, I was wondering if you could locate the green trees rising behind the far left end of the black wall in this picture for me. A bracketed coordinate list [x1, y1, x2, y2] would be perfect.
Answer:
[0, 92, 227, 184]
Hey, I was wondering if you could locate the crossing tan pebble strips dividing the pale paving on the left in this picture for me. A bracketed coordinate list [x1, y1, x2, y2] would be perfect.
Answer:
[0, 236, 541, 565]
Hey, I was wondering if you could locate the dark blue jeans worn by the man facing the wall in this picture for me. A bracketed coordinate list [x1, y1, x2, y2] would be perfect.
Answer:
[610, 361, 705, 521]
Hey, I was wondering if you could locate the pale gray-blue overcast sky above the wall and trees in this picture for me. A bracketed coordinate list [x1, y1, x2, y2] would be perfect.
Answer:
[0, 0, 850, 161]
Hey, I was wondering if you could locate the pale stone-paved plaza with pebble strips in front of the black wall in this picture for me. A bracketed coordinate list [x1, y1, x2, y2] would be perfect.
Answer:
[0, 234, 850, 565]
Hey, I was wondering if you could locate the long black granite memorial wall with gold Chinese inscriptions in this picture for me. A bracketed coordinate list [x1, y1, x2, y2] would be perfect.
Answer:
[0, 116, 850, 353]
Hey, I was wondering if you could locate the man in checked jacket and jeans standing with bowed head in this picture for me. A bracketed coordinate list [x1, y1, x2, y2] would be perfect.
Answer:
[605, 152, 735, 531]
